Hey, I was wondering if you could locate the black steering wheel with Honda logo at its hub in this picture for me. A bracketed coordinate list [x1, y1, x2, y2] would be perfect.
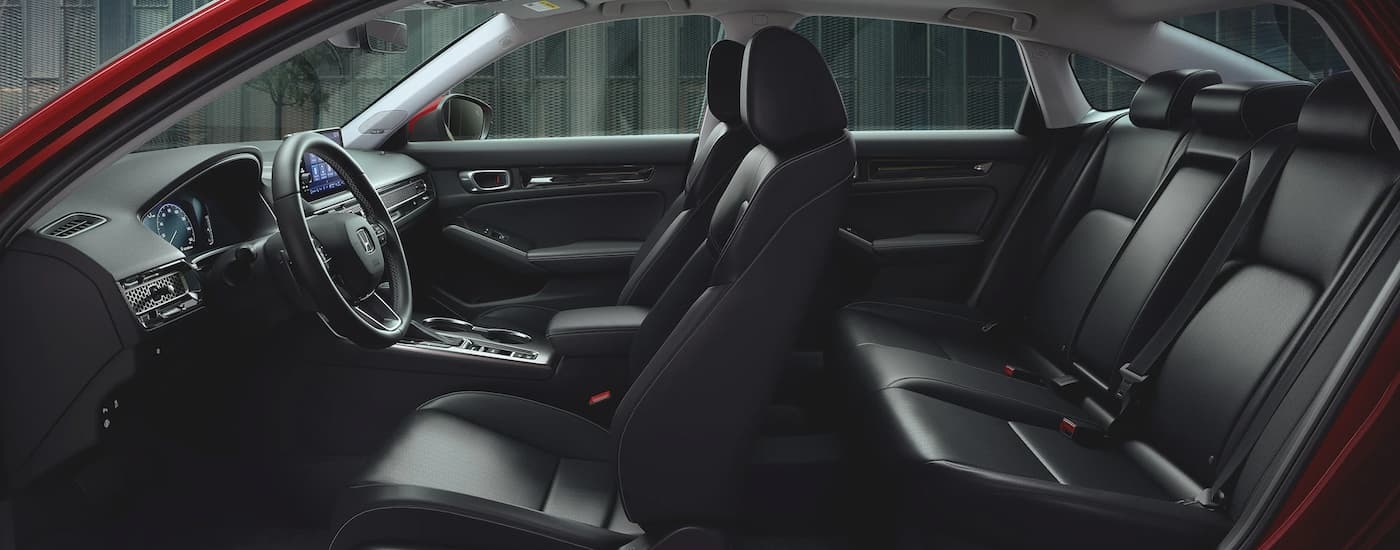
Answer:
[272, 132, 413, 348]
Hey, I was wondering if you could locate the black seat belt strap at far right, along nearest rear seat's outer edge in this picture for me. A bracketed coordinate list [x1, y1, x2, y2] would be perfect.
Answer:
[1191, 185, 1400, 509]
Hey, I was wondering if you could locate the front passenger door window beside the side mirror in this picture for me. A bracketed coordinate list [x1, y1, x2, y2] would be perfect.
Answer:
[452, 15, 720, 139]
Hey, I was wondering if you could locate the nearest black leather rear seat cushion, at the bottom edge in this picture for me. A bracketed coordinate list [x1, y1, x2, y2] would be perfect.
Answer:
[869, 389, 1229, 549]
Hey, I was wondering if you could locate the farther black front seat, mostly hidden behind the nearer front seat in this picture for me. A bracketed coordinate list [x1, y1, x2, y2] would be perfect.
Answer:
[475, 41, 756, 336]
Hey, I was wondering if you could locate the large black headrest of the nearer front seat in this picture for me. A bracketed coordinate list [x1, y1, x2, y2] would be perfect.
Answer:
[742, 27, 846, 151]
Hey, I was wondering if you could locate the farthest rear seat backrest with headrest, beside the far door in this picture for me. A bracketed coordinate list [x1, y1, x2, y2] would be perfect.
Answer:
[1025, 70, 1221, 350]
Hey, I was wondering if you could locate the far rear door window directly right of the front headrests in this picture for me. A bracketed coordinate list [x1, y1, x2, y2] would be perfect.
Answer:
[797, 17, 1026, 130]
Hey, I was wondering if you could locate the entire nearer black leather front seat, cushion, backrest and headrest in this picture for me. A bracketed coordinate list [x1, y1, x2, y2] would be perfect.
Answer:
[332, 28, 855, 549]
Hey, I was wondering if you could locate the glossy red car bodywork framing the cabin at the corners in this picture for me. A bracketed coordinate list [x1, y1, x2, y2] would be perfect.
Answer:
[0, 0, 1400, 549]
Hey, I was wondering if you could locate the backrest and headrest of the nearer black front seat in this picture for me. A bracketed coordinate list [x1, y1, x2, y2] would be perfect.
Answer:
[610, 28, 855, 528]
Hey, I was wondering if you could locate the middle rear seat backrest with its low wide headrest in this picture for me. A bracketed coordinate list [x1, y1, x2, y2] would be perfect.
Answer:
[1072, 81, 1312, 388]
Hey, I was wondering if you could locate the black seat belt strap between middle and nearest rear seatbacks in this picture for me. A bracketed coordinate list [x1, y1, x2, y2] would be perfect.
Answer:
[1114, 126, 1295, 411]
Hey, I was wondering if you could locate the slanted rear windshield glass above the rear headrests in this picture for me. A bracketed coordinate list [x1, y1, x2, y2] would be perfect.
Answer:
[1166, 4, 1347, 83]
